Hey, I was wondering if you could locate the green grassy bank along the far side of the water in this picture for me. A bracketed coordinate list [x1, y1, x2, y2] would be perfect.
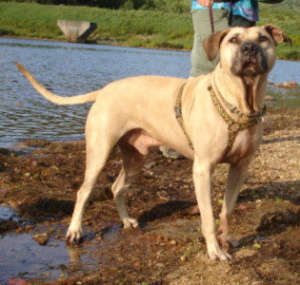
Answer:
[0, 2, 300, 59]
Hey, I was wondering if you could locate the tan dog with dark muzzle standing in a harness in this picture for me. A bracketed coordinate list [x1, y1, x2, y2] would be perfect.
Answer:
[17, 25, 289, 260]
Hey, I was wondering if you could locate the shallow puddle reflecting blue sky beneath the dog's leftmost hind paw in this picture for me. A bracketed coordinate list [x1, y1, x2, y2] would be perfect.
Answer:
[0, 219, 123, 284]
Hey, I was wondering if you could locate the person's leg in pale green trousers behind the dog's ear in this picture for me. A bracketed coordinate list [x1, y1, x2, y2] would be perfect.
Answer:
[190, 9, 229, 77]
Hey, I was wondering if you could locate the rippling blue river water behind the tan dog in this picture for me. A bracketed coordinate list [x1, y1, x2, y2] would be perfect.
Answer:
[0, 38, 300, 147]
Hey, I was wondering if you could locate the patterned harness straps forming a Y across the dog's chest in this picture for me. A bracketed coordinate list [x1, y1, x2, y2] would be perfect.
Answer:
[207, 86, 266, 154]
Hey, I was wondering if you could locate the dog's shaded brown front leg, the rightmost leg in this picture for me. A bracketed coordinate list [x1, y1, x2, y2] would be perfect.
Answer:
[218, 159, 250, 249]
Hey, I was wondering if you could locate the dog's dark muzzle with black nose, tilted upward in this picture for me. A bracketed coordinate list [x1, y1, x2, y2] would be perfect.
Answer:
[232, 42, 268, 76]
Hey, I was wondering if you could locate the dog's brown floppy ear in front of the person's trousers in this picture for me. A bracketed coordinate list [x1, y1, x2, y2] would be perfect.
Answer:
[202, 29, 229, 61]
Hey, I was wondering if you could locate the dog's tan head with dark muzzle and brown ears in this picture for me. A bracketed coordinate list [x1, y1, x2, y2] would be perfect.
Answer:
[203, 25, 291, 77]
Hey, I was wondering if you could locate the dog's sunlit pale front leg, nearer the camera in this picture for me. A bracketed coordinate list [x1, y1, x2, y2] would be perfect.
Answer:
[193, 156, 231, 260]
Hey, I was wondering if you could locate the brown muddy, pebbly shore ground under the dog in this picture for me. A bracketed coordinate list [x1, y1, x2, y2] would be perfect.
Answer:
[0, 108, 300, 285]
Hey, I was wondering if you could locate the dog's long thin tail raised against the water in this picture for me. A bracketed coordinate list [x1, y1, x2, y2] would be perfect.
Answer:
[15, 62, 99, 105]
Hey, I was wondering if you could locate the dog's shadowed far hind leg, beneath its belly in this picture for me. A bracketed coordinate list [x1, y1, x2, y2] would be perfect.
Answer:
[112, 144, 145, 228]
